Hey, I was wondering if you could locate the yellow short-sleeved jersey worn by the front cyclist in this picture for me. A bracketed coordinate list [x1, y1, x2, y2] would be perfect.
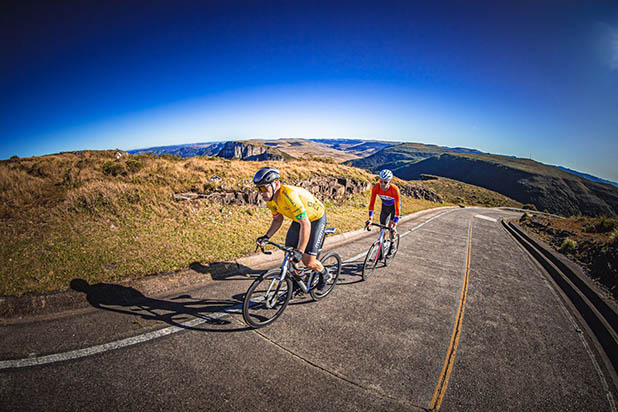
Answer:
[266, 185, 324, 222]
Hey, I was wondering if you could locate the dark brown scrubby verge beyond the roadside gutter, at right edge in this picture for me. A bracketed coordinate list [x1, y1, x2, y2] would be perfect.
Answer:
[520, 214, 618, 299]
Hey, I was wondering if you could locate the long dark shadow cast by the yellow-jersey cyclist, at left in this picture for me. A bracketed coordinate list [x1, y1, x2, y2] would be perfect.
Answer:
[70, 279, 248, 332]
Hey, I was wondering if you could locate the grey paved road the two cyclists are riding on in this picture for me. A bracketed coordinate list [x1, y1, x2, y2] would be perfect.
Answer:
[0, 209, 617, 412]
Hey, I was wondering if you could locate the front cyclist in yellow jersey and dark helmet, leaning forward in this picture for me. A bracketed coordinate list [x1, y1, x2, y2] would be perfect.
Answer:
[253, 167, 332, 289]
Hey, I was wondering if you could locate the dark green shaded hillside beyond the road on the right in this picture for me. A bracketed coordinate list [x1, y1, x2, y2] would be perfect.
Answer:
[393, 154, 618, 216]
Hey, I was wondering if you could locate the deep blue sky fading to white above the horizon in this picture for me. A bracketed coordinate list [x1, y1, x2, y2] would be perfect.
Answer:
[0, 0, 618, 181]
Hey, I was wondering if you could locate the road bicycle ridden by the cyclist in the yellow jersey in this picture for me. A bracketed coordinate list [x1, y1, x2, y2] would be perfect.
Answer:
[242, 228, 341, 328]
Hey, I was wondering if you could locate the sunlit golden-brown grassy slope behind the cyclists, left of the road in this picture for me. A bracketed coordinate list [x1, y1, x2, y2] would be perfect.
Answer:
[0, 151, 435, 296]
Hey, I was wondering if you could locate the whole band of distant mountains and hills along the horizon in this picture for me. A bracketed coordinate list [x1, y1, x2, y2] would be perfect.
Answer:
[125, 139, 618, 216]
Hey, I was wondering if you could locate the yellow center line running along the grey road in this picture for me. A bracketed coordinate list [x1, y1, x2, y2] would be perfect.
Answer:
[429, 217, 474, 411]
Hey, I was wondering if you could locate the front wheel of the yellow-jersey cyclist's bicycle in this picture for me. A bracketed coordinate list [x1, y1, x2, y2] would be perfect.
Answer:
[242, 268, 292, 328]
